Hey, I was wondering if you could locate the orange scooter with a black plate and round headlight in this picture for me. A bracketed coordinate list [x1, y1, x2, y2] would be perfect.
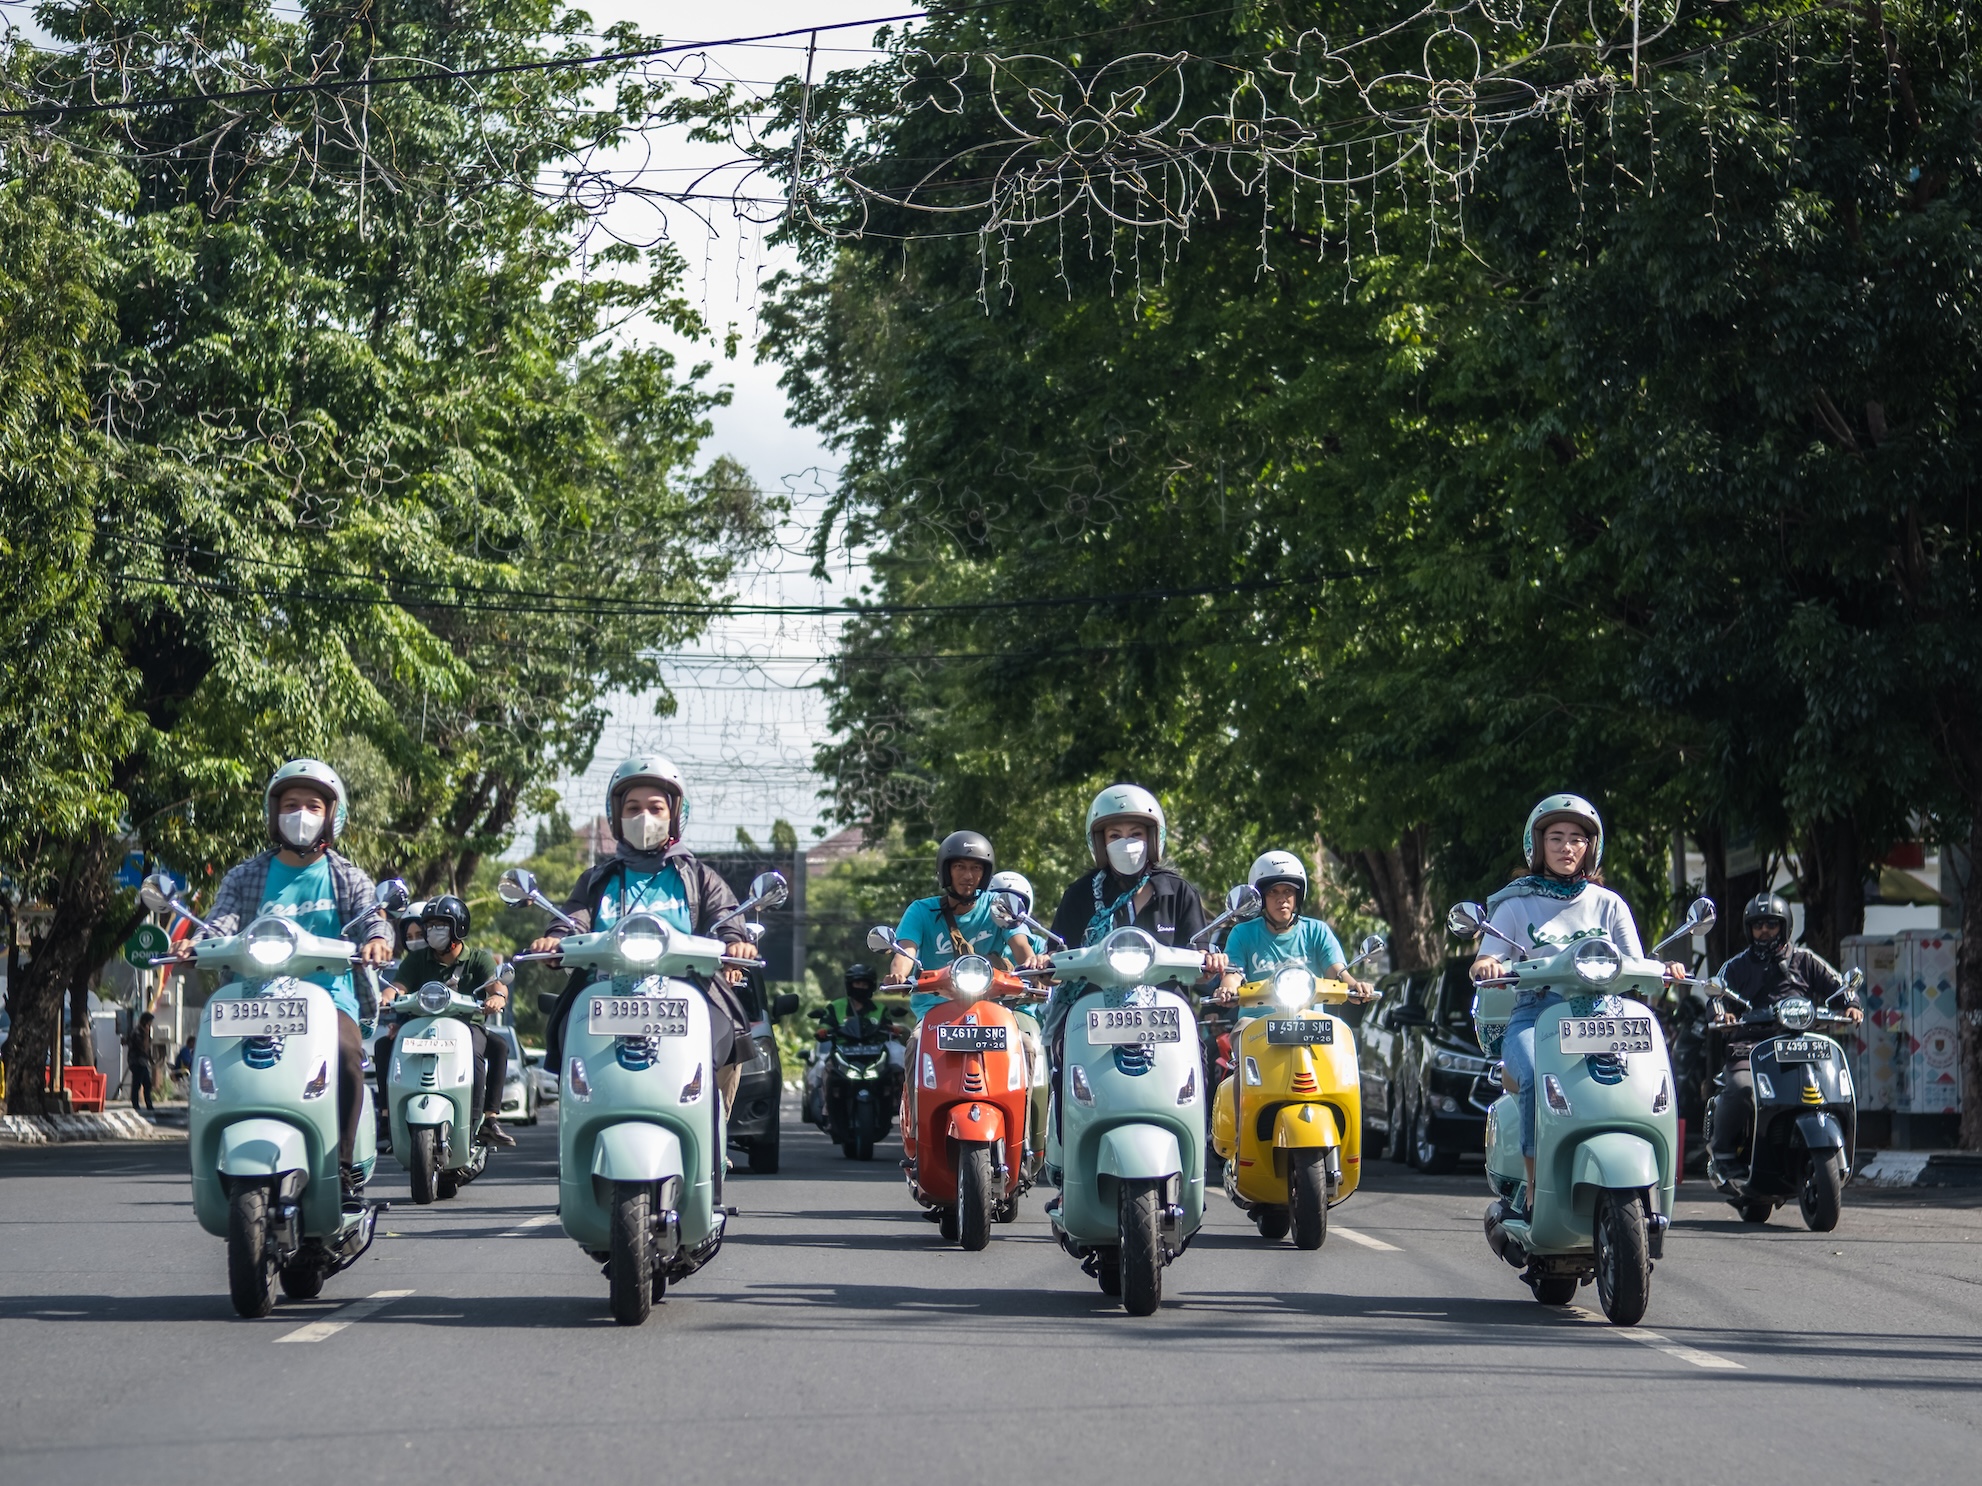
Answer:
[868, 925, 1039, 1250]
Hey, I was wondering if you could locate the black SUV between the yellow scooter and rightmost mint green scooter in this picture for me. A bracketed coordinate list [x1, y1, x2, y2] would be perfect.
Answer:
[1356, 959, 1500, 1173]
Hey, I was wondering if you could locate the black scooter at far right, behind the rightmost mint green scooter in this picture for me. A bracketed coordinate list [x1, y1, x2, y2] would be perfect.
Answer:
[1707, 971, 1865, 1232]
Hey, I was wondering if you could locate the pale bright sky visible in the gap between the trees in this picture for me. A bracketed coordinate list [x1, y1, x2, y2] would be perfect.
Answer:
[535, 0, 914, 850]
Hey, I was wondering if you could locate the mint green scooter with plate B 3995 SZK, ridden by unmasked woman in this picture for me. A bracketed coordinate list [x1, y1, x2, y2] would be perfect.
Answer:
[1445, 898, 1714, 1326]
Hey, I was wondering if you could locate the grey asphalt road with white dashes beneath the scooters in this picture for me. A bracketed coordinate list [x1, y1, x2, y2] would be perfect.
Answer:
[0, 1110, 1982, 1486]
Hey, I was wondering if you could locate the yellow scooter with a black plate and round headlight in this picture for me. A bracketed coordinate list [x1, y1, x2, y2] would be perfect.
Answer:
[1211, 935, 1383, 1248]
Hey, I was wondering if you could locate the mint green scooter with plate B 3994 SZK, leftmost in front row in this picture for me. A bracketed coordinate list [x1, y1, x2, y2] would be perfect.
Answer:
[139, 874, 406, 1316]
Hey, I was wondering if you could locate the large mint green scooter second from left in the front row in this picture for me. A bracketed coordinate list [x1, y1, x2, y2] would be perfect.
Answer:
[496, 868, 787, 1326]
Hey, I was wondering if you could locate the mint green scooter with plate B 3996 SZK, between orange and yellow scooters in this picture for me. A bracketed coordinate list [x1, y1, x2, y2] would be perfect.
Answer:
[1022, 888, 1259, 1316]
